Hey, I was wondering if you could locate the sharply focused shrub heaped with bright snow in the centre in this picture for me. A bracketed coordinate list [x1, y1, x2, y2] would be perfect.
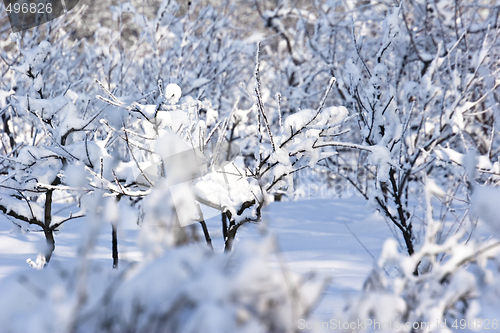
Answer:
[98, 59, 347, 250]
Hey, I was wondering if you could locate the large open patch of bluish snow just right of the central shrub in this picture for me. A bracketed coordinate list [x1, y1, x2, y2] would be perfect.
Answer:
[239, 198, 391, 319]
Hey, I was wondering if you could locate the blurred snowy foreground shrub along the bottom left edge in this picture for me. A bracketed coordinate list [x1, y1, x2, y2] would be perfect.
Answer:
[0, 239, 322, 333]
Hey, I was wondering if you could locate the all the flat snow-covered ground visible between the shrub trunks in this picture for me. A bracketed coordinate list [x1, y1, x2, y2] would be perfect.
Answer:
[0, 197, 391, 320]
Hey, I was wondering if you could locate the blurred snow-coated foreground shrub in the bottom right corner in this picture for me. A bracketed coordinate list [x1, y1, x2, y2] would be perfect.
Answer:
[342, 178, 500, 332]
